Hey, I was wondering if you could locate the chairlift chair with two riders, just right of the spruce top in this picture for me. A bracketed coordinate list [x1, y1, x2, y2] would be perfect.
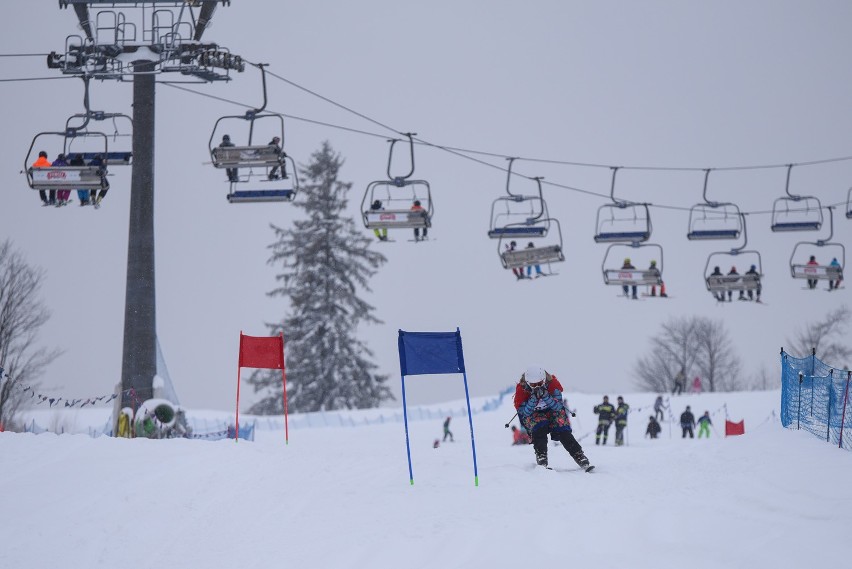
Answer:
[361, 133, 434, 229]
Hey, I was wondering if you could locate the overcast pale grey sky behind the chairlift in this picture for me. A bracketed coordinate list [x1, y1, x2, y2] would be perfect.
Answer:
[0, 0, 852, 409]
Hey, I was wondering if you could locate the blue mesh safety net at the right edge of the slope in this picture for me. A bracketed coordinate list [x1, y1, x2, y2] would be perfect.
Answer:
[781, 352, 852, 450]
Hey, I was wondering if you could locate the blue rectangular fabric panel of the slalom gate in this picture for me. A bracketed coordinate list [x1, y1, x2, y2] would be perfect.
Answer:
[399, 330, 464, 375]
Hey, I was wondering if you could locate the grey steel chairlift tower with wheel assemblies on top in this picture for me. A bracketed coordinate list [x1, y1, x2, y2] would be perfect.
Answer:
[47, 0, 244, 411]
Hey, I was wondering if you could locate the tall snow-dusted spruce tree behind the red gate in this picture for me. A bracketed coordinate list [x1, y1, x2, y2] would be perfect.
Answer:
[248, 142, 393, 414]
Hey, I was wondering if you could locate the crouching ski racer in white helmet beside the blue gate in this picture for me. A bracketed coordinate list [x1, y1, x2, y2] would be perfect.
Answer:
[515, 366, 593, 472]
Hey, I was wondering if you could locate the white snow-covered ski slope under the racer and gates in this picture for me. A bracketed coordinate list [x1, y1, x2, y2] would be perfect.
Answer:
[0, 391, 852, 569]
